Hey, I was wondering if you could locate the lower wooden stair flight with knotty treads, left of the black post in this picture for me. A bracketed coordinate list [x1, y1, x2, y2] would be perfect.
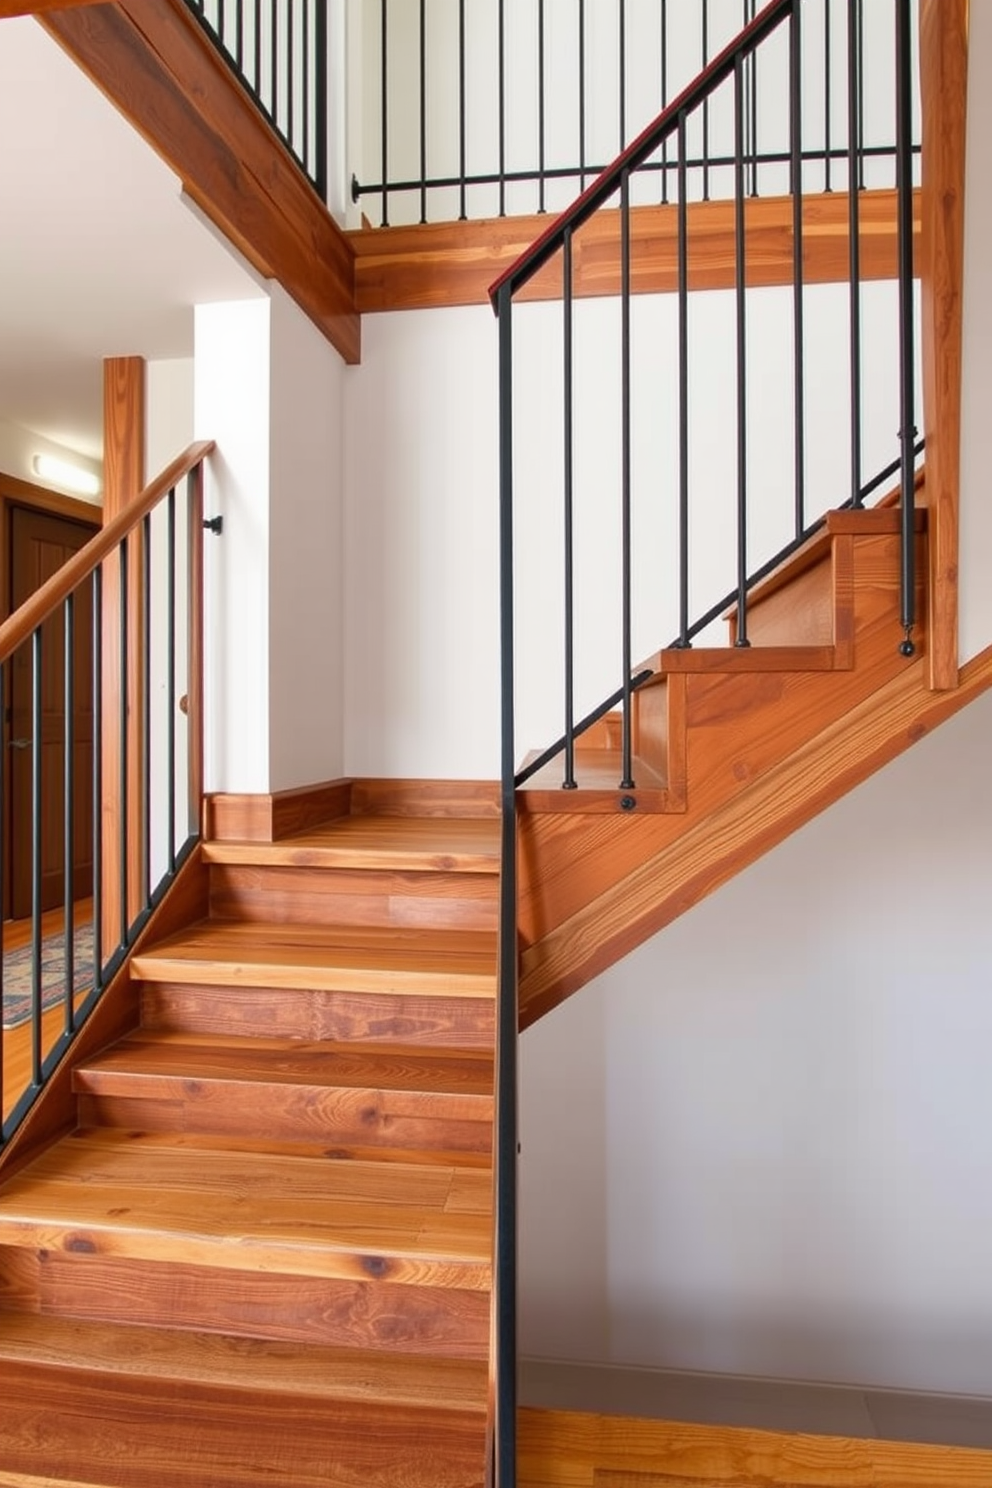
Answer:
[0, 801, 498, 1488]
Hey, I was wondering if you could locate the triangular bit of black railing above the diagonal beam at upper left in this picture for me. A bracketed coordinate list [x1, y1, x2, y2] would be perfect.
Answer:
[186, 0, 327, 201]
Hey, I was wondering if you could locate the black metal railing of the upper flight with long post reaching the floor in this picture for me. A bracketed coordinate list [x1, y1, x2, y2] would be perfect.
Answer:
[491, 0, 921, 1488]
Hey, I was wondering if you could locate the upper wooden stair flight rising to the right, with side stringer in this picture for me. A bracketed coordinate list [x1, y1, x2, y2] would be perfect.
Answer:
[518, 499, 945, 1025]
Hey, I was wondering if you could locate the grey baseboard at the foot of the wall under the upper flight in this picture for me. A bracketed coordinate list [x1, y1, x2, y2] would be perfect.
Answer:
[519, 1360, 992, 1448]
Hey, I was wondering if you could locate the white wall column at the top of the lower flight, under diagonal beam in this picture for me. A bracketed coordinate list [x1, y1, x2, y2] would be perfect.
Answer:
[195, 293, 344, 792]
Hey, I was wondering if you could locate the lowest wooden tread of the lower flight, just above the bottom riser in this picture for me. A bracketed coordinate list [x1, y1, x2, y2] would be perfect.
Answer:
[0, 1312, 488, 1414]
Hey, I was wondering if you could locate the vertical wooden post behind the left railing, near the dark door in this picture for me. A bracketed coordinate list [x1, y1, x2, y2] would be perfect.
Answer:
[101, 357, 144, 955]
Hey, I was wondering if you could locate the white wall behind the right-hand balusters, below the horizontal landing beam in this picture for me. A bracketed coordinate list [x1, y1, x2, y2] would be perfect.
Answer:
[345, 283, 922, 777]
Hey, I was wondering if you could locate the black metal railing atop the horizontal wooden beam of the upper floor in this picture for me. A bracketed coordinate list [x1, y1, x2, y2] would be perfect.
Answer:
[350, 0, 922, 226]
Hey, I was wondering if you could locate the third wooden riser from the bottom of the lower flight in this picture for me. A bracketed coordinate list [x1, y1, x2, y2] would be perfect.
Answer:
[79, 1071, 492, 1155]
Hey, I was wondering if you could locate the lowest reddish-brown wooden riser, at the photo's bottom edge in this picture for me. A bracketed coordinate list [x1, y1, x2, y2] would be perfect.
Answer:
[0, 1363, 485, 1488]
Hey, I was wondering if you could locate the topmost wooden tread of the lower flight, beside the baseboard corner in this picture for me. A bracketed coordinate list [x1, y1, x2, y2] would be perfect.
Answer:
[204, 815, 500, 873]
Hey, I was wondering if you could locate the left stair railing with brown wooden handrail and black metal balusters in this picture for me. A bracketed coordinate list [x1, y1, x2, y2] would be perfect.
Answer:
[0, 443, 213, 1150]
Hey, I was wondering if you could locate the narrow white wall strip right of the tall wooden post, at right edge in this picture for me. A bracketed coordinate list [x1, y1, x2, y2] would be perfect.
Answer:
[959, 4, 992, 662]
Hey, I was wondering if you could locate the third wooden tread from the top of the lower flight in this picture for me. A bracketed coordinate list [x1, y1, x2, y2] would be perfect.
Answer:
[74, 1031, 492, 1097]
